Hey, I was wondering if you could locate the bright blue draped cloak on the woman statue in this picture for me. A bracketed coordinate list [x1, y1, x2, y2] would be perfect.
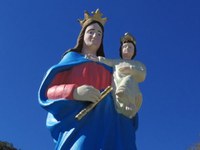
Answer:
[38, 52, 138, 150]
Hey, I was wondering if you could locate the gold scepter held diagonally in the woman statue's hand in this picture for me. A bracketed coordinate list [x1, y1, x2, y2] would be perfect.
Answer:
[75, 86, 113, 120]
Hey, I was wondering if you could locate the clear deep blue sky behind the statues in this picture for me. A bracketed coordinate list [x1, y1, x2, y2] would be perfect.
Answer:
[0, 0, 200, 150]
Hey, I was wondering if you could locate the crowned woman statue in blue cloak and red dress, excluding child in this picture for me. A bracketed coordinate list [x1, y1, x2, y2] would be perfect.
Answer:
[39, 9, 141, 150]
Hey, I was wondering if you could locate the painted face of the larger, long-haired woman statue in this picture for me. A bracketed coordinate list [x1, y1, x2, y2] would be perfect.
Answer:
[84, 23, 103, 53]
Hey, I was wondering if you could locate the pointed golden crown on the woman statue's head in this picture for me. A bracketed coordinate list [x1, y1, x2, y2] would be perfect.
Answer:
[78, 9, 107, 27]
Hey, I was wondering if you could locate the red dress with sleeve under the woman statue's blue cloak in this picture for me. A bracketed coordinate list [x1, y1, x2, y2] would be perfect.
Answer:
[46, 62, 111, 99]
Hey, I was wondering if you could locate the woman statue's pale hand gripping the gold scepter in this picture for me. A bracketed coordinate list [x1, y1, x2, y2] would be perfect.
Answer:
[73, 85, 101, 102]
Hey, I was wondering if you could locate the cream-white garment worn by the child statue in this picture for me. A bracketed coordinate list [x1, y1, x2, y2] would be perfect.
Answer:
[98, 57, 146, 118]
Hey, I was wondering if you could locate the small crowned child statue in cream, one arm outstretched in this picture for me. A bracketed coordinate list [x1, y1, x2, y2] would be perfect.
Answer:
[87, 33, 146, 118]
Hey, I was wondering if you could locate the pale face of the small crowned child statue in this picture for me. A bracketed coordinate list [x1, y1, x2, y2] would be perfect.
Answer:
[122, 43, 135, 60]
